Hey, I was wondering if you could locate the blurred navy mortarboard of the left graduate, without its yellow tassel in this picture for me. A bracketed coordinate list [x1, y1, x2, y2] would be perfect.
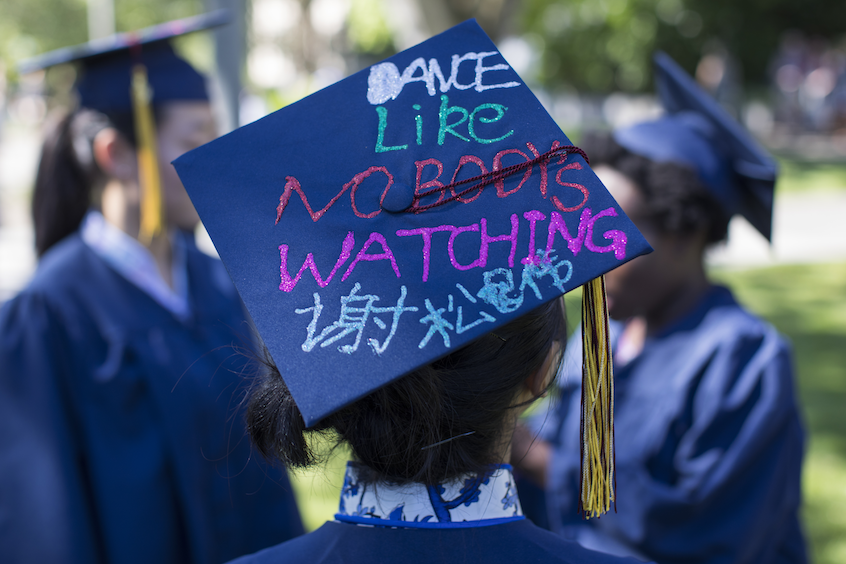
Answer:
[18, 10, 230, 113]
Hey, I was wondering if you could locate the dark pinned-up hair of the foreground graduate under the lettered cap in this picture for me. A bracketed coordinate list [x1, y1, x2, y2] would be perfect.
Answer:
[246, 298, 566, 485]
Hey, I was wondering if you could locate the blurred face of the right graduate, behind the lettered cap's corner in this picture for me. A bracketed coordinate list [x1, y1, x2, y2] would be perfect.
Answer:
[594, 165, 690, 320]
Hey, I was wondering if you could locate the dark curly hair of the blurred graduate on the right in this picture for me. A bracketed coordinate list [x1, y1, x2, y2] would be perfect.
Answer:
[580, 132, 730, 245]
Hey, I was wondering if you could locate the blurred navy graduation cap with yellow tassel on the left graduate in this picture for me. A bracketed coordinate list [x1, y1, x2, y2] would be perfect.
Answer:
[18, 10, 230, 243]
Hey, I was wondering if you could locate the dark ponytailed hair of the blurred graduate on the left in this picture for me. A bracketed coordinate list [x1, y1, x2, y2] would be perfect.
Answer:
[32, 108, 150, 257]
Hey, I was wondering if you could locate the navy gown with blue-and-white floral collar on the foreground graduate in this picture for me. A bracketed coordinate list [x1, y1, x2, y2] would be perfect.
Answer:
[225, 465, 638, 564]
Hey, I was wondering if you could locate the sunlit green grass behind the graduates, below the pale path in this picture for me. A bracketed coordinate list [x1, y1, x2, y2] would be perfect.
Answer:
[292, 263, 846, 564]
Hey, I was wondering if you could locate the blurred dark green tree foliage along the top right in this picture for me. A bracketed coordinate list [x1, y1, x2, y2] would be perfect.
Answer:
[522, 0, 846, 92]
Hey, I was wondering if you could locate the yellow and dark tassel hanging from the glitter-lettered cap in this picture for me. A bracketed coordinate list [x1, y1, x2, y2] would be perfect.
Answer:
[579, 276, 615, 519]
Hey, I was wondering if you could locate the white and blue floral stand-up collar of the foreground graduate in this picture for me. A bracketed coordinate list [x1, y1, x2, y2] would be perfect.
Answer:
[335, 462, 525, 529]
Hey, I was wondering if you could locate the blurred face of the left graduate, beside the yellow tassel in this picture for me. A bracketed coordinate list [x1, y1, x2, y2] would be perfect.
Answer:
[157, 101, 217, 230]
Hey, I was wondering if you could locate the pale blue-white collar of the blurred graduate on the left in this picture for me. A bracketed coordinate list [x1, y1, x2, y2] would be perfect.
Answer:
[80, 210, 191, 321]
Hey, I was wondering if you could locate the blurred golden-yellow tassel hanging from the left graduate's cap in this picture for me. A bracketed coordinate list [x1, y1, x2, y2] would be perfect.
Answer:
[132, 64, 164, 245]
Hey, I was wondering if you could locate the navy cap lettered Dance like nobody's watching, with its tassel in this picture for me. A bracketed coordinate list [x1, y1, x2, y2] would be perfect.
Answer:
[174, 20, 650, 510]
